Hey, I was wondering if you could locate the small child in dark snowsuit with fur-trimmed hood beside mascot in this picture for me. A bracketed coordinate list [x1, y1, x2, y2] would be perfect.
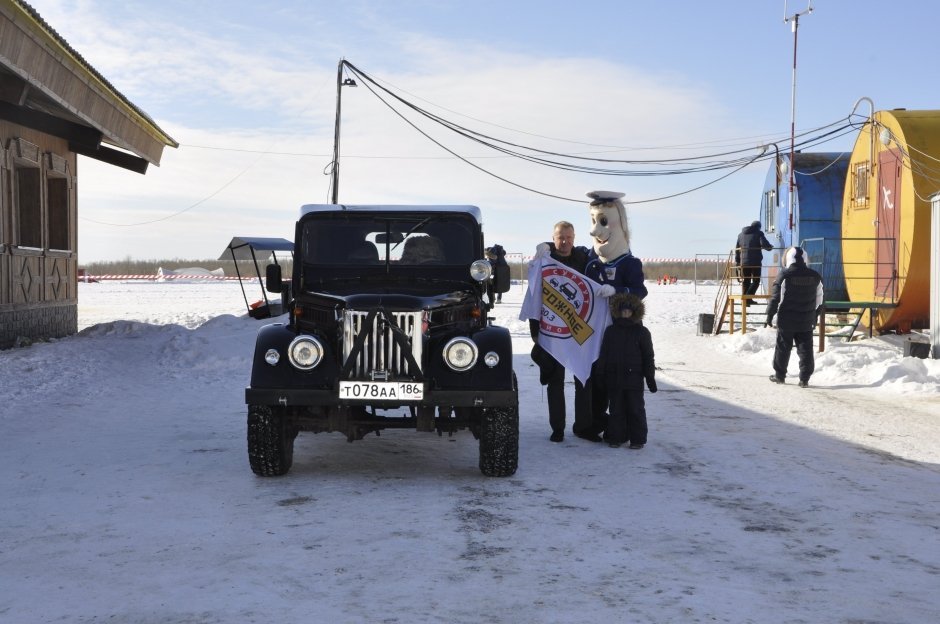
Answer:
[594, 293, 656, 449]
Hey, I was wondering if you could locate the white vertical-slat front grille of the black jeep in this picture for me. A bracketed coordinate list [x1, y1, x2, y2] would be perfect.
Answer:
[343, 310, 423, 379]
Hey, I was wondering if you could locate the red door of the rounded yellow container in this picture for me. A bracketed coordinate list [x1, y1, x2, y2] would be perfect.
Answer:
[875, 149, 901, 300]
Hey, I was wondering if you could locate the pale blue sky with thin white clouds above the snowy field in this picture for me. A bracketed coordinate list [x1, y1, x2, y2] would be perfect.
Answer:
[25, 0, 940, 263]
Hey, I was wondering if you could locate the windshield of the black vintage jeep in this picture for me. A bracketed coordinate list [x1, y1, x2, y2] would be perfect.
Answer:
[300, 212, 482, 290]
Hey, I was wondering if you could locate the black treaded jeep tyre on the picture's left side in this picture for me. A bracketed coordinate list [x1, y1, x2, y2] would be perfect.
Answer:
[248, 405, 297, 477]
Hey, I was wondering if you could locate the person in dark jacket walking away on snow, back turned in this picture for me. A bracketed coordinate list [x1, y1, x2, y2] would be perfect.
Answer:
[767, 247, 823, 388]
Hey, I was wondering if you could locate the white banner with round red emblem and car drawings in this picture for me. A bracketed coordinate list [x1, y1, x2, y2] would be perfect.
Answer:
[519, 258, 611, 383]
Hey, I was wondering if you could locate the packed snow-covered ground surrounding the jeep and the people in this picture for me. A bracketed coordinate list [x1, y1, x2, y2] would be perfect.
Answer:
[0, 282, 940, 624]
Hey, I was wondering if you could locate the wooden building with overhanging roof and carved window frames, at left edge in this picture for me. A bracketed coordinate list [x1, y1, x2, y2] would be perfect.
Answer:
[0, 0, 177, 348]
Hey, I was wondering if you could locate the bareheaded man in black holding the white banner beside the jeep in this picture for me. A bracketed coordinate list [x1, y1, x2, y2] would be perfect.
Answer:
[529, 221, 600, 442]
